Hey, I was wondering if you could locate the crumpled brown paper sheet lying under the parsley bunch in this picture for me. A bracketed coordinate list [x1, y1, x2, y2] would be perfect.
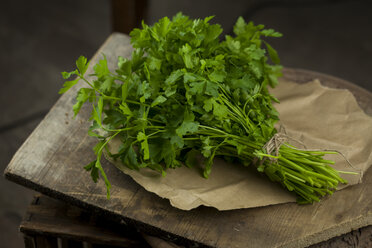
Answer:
[104, 80, 372, 210]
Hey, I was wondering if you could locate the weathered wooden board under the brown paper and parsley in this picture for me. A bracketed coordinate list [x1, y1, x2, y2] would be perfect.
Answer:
[5, 34, 372, 247]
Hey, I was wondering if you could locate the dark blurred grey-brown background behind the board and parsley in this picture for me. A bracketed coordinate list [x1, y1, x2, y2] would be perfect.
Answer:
[0, 0, 372, 248]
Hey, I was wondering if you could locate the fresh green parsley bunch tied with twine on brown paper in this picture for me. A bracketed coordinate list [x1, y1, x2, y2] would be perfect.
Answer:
[60, 13, 346, 203]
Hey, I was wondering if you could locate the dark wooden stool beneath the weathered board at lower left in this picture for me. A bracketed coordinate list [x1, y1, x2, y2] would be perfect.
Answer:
[20, 194, 182, 248]
